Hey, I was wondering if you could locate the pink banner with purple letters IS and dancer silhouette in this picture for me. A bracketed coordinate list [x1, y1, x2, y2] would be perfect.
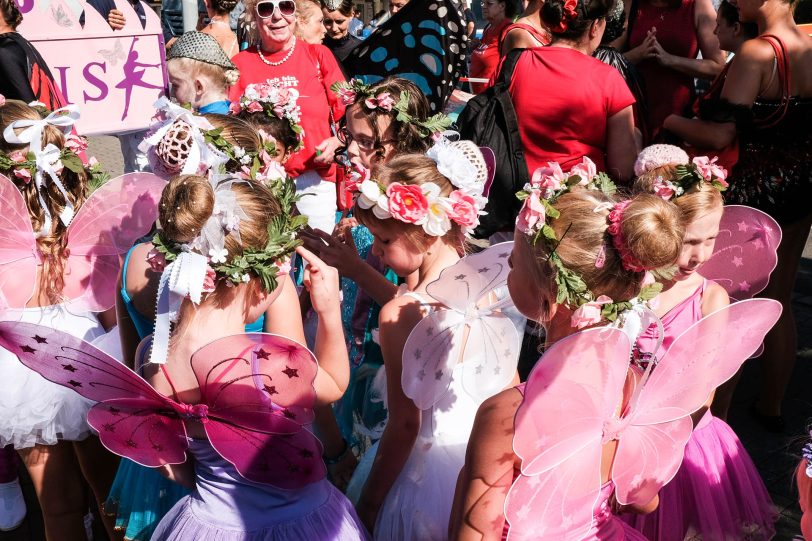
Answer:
[17, 0, 168, 135]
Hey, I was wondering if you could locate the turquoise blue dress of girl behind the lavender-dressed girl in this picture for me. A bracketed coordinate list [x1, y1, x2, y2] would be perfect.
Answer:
[104, 244, 265, 541]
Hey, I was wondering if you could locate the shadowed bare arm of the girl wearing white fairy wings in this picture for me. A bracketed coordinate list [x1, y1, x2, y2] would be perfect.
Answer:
[357, 297, 423, 531]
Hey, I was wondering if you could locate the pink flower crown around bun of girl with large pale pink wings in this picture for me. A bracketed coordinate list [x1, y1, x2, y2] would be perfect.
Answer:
[516, 157, 662, 329]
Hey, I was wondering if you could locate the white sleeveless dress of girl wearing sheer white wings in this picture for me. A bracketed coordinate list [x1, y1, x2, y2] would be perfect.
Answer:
[347, 292, 494, 541]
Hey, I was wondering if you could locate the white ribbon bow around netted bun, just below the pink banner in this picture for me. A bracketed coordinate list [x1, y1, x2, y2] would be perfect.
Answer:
[138, 96, 228, 175]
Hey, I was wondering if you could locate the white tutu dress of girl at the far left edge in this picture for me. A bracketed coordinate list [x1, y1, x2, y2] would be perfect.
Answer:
[0, 305, 104, 449]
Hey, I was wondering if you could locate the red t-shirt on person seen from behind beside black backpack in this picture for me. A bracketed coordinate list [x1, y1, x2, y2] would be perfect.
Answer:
[510, 47, 634, 174]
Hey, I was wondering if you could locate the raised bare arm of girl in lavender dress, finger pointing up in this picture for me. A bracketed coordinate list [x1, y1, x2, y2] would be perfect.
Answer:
[296, 246, 350, 405]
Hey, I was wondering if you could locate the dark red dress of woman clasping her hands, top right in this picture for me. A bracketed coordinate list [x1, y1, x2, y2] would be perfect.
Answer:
[629, 0, 699, 137]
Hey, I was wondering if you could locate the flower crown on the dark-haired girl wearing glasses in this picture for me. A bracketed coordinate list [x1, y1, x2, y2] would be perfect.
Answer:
[330, 78, 451, 137]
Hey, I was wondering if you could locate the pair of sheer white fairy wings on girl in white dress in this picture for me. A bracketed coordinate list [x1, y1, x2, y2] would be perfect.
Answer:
[401, 243, 520, 409]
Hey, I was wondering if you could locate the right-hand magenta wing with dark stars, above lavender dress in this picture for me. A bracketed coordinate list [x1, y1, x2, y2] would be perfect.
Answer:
[192, 333, 326, 489]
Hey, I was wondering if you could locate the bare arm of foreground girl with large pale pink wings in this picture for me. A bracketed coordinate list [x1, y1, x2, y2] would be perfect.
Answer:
[448, 389, 522, 541]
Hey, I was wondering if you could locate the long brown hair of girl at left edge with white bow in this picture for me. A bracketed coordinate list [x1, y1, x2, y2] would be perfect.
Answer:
[0, 100, 89, 304]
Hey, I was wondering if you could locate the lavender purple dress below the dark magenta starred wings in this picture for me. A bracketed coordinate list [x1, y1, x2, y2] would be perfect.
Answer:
[152, 439, 367, 541]
